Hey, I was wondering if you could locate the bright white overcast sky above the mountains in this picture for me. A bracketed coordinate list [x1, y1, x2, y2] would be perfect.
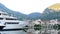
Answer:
[0, 0, 60, 14]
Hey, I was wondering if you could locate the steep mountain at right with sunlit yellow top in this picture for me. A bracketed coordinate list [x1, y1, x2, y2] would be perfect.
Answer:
[41, 4, 60, 20]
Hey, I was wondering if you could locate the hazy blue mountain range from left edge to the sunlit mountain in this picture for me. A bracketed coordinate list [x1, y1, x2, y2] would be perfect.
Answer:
[0, 3, 41, 20]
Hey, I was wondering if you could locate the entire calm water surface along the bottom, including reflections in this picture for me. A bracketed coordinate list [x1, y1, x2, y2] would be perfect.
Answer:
[0, 27, 60, 34]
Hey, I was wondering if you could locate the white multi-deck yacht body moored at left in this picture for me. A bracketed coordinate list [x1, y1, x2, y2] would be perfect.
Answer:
[0, 11, 23, 29]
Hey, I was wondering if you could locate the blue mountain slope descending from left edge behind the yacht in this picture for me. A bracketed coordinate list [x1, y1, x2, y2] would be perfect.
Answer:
[0, 3, 27, 20]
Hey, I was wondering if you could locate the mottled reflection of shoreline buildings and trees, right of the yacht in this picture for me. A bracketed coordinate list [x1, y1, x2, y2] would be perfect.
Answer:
[23, 26, 60, 34]
